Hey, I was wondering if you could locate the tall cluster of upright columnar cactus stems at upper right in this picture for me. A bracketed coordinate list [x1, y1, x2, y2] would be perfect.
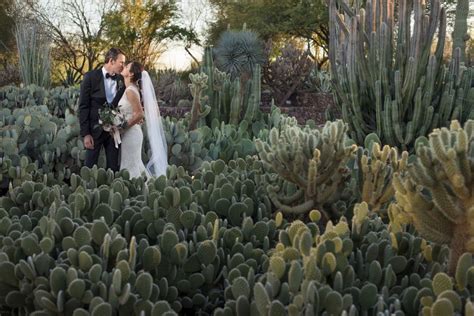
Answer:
[330, 0, 474, 150]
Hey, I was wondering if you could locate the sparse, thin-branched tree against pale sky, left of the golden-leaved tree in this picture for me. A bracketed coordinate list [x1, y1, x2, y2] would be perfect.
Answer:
[25, 0, 118, 84]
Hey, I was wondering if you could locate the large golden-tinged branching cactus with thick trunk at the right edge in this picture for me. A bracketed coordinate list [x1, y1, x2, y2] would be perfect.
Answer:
[393, 120, 474, 273]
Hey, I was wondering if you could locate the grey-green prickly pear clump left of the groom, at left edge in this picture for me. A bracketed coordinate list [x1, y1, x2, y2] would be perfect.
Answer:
[0, 106, 85, 182]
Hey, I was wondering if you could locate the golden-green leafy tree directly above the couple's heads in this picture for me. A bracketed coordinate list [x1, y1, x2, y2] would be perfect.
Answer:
[105, 0, 195, 68]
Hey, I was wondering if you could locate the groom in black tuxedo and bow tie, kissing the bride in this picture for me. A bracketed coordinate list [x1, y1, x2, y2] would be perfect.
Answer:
[79, 48, 125, 171]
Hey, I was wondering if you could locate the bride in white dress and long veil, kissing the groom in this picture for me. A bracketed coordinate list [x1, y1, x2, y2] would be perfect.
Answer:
[118, 62, 168, 178]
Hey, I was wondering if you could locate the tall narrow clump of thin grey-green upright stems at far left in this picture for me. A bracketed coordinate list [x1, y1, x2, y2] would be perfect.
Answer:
[15, 21, 51, 87]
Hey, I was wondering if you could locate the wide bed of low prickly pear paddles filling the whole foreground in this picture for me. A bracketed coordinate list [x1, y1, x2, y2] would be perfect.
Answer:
[0, 129, 474, 315]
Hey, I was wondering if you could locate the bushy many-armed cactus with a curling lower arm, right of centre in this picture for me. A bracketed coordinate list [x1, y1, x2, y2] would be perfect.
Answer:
[256, 120, 357, 220]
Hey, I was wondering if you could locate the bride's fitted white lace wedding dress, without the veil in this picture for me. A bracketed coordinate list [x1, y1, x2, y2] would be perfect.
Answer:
[118, 86, 150, 178]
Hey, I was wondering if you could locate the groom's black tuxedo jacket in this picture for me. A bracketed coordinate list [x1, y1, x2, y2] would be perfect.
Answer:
[79, 68, 125, 139]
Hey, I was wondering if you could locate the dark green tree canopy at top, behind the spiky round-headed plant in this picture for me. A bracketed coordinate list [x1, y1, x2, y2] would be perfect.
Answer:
[208, 0, 329, 65]
